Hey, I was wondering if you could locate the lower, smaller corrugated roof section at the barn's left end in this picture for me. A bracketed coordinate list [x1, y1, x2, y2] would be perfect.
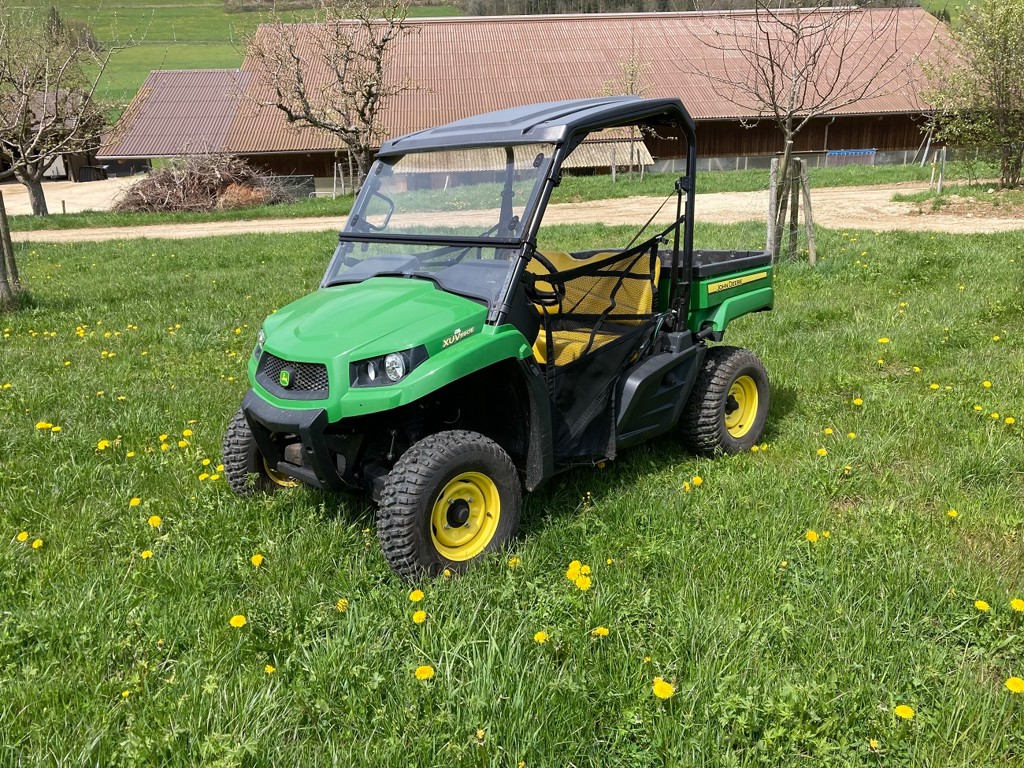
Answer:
[98, 70, 251, 159]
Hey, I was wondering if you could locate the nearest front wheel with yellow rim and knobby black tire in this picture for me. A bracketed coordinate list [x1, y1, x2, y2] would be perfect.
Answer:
[377, 430, 522, 581]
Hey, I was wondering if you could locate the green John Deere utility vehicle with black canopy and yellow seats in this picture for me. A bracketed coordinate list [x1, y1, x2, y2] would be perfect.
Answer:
[223, 96, 773, 579]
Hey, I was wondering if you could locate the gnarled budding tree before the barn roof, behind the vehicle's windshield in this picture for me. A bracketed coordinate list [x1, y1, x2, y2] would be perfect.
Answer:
[246, 0, 411, 186]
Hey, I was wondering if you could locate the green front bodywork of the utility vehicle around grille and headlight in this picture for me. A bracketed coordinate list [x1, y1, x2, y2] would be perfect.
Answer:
[249, 278, 532, 422]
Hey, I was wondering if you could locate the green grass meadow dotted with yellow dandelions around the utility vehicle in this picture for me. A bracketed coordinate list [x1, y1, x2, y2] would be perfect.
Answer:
[0, 219, 1024, 767]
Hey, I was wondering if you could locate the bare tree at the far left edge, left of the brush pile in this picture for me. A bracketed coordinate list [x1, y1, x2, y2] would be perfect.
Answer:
[0, 5, 130, 216]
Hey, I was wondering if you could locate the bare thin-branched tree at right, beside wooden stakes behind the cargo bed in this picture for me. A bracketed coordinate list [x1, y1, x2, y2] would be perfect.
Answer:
[700, 0, 934, 256]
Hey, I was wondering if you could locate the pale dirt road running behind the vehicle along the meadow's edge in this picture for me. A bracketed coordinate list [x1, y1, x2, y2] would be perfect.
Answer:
[13, 184, 1024, 243]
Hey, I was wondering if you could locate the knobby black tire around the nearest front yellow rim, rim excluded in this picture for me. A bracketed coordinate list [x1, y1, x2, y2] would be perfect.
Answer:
[377, 430, 522, 581]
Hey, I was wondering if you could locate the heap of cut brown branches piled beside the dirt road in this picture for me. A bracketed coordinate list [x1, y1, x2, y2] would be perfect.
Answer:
[114, 155, 294, 213]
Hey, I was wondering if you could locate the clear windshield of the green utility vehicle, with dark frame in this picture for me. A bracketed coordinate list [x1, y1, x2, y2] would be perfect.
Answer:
[324, 144, 554, 304]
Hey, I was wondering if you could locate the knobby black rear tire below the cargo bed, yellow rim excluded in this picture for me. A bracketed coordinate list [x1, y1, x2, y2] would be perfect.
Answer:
[679, 346, 771, 456]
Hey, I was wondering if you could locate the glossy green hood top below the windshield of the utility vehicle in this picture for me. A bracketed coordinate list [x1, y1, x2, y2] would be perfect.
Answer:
[263, 278, 487, 362]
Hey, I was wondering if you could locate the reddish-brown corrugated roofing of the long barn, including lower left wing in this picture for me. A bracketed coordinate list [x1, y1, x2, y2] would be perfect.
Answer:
[102, 8, 948, 157]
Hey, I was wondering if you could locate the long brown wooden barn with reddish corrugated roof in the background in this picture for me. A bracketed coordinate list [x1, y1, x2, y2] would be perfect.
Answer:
[100, 8, 948, 178]
